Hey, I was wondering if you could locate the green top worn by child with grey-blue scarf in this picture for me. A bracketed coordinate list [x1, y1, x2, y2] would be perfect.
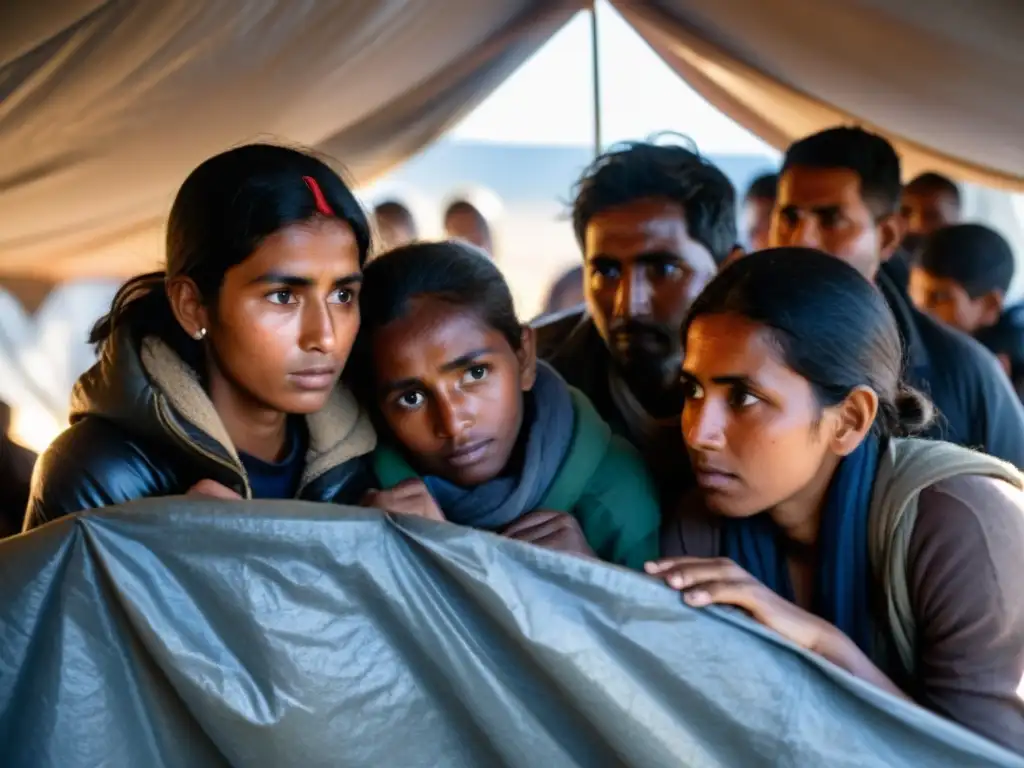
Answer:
[372, 387, 662, 570]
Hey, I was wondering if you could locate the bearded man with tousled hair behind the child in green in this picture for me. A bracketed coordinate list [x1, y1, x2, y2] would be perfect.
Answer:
[537, 137, 736, 502]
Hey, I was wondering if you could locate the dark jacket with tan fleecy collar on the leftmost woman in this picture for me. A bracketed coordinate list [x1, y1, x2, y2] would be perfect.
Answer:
[25, 332, 377, 529]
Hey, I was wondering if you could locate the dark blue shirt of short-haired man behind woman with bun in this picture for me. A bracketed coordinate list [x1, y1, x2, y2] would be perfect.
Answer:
[878, 269, 1024, 468]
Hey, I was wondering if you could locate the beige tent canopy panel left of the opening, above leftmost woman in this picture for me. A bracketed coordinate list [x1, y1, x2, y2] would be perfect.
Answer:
[0, 0, 583, 279]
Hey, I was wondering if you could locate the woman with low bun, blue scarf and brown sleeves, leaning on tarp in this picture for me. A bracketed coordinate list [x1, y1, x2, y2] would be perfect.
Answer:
[646, 248, 1024, 752]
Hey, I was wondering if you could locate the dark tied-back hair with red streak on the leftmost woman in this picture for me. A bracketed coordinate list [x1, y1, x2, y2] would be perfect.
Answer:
[89, 144, 371, 368]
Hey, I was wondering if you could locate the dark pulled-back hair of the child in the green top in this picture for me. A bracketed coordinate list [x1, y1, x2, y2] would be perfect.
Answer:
[346, 241, 522, 395]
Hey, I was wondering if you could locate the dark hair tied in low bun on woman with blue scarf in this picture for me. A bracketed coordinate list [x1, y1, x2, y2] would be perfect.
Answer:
[683, 248, 934, 437]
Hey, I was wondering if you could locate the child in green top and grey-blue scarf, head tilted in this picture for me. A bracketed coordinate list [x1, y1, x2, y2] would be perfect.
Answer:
[351, 242, 660, 569]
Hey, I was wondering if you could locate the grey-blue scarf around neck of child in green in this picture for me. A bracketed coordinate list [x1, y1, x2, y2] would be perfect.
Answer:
[424, 362, 575, 530]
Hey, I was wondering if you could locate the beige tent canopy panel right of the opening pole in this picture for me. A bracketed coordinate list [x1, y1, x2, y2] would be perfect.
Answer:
[611, 0, 1024, 190]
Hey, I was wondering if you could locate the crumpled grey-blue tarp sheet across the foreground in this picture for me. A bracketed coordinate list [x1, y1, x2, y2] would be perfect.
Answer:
[0, 499, 1024, 768]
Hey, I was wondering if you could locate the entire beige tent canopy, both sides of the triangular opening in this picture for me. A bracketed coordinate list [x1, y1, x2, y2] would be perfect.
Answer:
[0, 0, 1024, 279]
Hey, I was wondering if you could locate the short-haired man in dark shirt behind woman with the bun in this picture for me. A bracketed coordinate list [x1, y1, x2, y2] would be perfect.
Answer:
[771, 128, 1024, 467]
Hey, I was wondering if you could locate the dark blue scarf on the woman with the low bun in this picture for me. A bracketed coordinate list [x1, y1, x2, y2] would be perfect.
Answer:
[722, 436, 879, 656]
